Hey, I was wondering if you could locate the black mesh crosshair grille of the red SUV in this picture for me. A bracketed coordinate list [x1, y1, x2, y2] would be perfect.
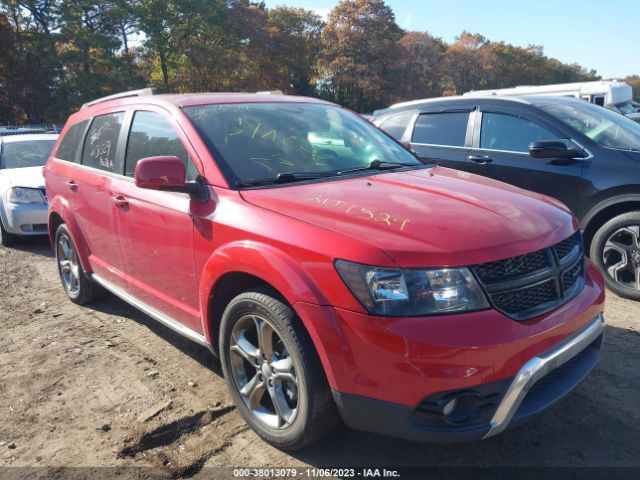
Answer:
[473, 232, 584, 320]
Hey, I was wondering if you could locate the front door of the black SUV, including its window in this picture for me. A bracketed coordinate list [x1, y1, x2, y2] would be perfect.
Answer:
[468, 106, 584, 212]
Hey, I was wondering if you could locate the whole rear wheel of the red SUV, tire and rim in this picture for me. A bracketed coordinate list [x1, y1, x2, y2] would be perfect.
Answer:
[55, 223, 104, 305]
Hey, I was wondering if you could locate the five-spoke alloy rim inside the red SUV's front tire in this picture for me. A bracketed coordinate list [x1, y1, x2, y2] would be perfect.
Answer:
[229, 315, 298, 429]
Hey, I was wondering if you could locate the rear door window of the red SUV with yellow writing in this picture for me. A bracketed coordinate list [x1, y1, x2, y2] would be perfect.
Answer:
[82, 112, 124, 173]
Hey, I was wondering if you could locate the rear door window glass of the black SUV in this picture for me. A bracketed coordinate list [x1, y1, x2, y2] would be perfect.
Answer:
[411, 112, 469, 147]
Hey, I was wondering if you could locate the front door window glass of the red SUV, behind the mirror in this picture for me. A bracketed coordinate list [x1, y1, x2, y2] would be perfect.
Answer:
[125, 111, 198, 180]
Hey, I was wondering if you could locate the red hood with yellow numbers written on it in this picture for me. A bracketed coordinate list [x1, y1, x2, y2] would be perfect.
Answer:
[241, 167, 576, 267]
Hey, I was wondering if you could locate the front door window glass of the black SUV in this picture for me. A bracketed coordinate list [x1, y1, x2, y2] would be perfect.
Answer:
[480, 112, 560, 153]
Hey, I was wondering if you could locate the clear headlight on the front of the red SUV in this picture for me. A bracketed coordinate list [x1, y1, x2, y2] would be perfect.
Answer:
[336, 260, 489, 317]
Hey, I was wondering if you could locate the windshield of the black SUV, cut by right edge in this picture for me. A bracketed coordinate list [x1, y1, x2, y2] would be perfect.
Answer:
[540, 103, 640, 150]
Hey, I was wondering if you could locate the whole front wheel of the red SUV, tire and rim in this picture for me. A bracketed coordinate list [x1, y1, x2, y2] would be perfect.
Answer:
[220, 289, 340, 450]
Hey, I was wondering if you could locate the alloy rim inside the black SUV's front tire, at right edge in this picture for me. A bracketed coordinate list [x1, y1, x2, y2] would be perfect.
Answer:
[602, 225, 640, 290]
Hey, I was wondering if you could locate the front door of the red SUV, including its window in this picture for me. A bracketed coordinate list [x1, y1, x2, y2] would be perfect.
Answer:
[111, 107, 202, 333]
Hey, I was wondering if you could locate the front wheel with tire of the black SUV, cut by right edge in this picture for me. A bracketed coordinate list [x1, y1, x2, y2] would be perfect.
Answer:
[589, 212, 640, 301]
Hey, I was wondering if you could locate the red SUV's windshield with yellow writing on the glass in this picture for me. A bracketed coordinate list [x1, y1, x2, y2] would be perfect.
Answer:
[184, 103, 423, 184]
